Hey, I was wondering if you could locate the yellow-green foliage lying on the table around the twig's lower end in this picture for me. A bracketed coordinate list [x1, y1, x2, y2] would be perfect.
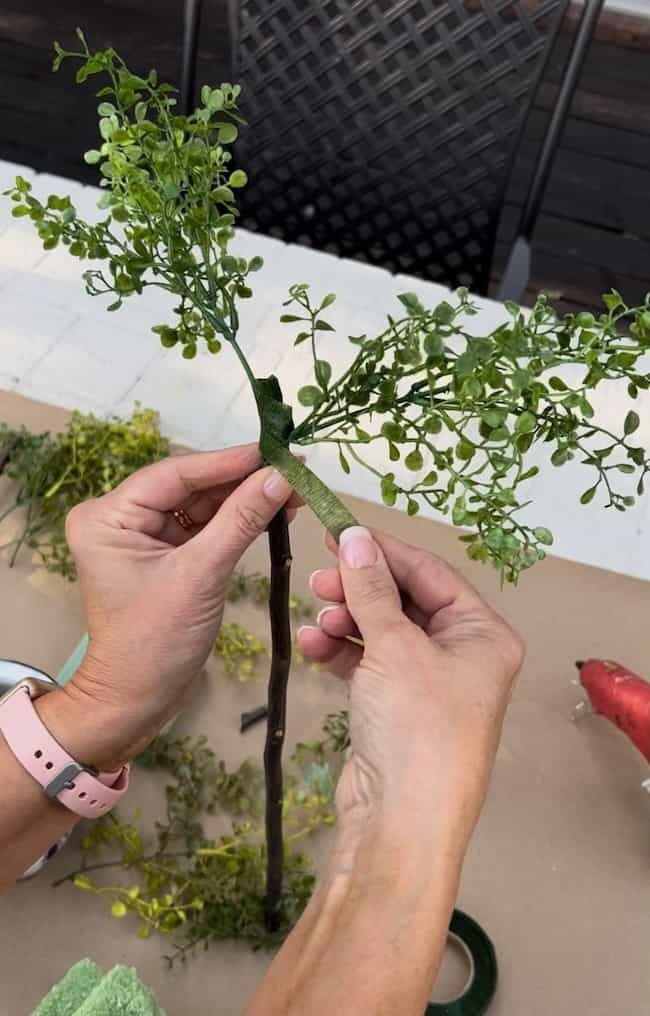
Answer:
[65, 714, 344, 962]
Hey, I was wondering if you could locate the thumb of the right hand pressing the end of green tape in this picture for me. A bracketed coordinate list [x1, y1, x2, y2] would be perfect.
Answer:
[338, 525, 403, 641]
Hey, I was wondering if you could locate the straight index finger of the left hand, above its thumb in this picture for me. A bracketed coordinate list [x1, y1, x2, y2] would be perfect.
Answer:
[110, 444, 261, 512]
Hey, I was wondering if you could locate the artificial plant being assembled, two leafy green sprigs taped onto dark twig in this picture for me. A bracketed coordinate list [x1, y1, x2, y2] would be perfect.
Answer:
[9, 30, 650, 926]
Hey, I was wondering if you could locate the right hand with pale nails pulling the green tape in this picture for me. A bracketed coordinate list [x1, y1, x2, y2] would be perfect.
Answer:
[300, 527, 523, 840]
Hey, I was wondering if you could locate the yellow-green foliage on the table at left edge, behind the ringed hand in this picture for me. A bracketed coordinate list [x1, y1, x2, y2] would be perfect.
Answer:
[0, 405, 170, 579]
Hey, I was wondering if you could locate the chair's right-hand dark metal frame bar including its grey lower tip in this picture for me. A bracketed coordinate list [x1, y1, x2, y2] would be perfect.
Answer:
[499, 0, 604, 303]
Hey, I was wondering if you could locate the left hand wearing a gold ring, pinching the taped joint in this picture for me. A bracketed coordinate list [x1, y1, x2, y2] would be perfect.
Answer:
[45, 445, 298, 769]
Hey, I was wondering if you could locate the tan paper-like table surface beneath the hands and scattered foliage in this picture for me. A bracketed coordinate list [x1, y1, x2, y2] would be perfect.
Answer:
[0, 393, 650, 1016]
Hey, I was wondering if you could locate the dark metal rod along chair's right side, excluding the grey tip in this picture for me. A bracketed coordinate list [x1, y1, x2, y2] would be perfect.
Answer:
[517, 0, 604, 240]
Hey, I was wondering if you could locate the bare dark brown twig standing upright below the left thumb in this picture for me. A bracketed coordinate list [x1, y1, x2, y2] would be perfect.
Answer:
[264, 509, 291, 932]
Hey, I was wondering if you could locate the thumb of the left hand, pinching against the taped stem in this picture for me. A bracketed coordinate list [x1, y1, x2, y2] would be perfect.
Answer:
[183, 467, 293, 577]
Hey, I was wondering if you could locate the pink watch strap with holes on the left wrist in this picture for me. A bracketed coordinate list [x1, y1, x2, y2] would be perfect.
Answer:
[0, 685, 129, 819]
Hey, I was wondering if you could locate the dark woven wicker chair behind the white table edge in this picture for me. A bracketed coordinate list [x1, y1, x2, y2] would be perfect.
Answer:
[184, 0, 603, 298]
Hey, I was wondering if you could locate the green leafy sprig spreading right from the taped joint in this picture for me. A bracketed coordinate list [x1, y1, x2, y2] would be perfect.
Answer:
[283, 285, 650, 581]
